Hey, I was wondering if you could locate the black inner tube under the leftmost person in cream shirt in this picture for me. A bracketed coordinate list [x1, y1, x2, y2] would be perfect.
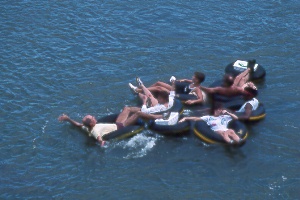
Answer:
[97, 114, 144, 140]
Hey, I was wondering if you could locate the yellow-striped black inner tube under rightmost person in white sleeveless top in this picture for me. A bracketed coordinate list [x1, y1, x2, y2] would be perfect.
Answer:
[223, 100, 266, 121]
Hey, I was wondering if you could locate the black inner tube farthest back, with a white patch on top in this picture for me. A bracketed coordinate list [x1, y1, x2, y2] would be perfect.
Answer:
[225, 60, 266, 81]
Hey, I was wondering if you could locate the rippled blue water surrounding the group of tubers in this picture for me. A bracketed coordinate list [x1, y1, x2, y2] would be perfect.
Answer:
[0, 0, 300, 199]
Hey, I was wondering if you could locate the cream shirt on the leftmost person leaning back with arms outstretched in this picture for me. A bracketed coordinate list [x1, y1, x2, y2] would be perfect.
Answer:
[82, 123, 117, 139]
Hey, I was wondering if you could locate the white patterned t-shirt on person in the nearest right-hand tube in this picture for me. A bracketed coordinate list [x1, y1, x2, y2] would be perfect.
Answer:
[200, 115, 232, 131]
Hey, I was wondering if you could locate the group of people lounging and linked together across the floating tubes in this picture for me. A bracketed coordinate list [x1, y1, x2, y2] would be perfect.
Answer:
[58, 61, 259, 145]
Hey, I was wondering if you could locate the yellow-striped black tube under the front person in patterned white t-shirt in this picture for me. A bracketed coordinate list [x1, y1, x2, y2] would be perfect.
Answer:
[193, 120, 248, 144]
